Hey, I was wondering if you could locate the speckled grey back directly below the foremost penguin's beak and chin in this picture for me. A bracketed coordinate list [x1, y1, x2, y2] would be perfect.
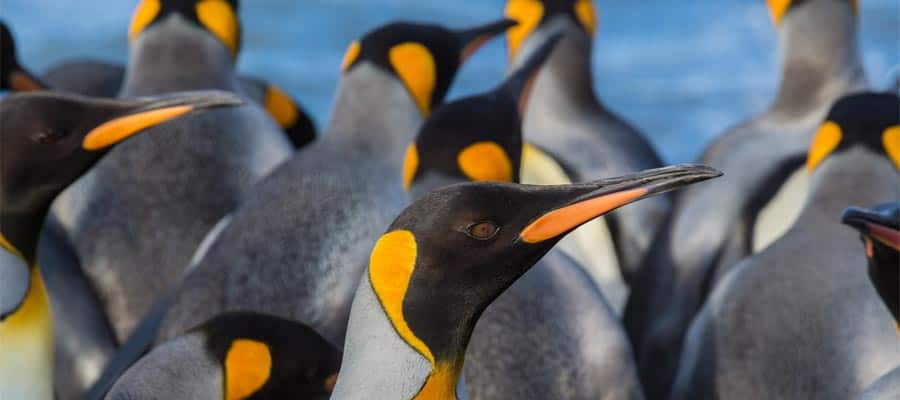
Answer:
[463, 250, 644, 400]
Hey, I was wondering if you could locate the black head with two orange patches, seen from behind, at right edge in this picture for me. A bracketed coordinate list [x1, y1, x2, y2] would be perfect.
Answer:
[806, 93, 900, 172]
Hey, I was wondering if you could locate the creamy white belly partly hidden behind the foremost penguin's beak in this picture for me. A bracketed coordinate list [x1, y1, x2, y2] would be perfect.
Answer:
[520, 145, 628, 316]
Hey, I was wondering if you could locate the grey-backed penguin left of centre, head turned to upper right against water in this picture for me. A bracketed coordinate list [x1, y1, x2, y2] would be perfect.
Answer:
[158, 20, 512, 347]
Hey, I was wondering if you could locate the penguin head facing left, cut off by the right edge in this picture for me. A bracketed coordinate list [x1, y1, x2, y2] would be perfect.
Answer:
[842, 201, 900, 327]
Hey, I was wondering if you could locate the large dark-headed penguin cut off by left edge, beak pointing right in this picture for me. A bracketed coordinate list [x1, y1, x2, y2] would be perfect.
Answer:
[0, 92, 240, 399]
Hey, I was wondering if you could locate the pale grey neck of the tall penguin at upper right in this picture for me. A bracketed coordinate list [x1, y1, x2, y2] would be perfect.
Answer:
[772, 2, 867, 116]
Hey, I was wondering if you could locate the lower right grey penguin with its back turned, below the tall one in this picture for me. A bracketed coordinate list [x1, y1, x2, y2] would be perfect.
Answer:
[671, 93, 900, 400]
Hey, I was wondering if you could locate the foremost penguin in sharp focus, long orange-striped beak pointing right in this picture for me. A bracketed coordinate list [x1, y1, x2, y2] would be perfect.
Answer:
[332, 165, 719, 400]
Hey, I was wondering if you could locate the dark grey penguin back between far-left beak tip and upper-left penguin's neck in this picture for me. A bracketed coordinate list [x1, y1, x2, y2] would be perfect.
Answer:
[41, 59, 125, 97]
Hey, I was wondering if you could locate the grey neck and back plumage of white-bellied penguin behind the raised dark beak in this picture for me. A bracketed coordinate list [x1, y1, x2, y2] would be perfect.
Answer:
[512, 15, 669, 281]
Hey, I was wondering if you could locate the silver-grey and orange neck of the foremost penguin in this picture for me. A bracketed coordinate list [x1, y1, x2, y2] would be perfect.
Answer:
[332, 279, 474, 399]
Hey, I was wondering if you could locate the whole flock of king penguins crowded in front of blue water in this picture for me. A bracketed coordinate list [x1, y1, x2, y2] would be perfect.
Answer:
[0, 0, 900, 400]
